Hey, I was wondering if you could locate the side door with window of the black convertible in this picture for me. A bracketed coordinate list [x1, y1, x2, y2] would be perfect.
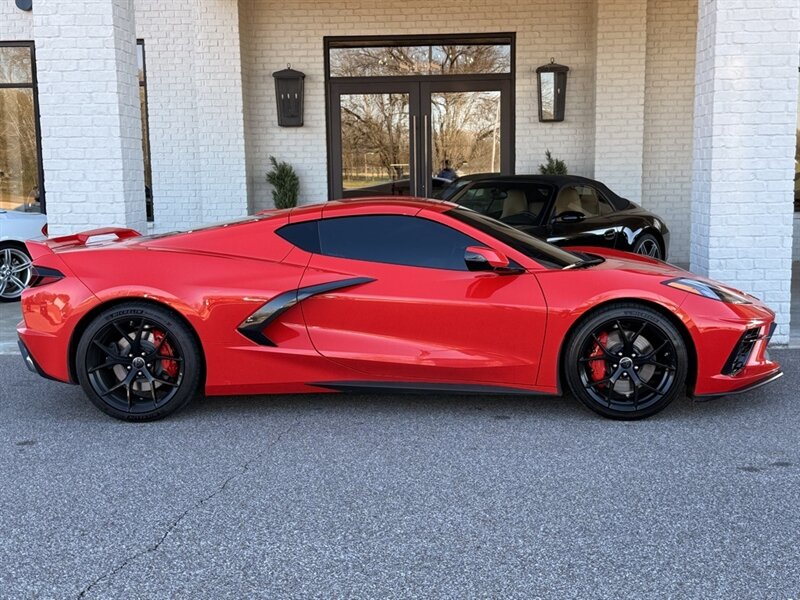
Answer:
[547, 184, 621, 248]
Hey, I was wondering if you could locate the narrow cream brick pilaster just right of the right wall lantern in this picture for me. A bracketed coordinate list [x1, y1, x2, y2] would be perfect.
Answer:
[594, 0, 647, 202]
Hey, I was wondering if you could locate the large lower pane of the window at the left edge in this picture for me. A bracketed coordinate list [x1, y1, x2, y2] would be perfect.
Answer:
[0, 88, 41, 212]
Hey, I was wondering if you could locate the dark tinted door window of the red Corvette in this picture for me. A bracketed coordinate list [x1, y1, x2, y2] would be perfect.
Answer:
[319, 215, 480, 271]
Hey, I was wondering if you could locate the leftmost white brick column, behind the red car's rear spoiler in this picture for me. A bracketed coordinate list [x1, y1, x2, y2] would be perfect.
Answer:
[34, 0, 145, 234]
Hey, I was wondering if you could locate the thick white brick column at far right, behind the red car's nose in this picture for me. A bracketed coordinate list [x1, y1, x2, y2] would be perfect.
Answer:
[691, 0, 800, 343]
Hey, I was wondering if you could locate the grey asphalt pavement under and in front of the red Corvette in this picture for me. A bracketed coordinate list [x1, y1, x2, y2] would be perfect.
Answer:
[0, 350, 800, 599]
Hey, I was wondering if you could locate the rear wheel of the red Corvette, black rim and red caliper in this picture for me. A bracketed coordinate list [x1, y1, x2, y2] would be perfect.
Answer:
[75, 301, 203, 421]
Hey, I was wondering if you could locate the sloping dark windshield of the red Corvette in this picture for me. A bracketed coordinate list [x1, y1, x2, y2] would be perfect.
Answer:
[445, 206, 582, 269]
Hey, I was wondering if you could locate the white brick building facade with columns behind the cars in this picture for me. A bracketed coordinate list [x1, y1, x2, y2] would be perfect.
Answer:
[0, 0, 800, 342]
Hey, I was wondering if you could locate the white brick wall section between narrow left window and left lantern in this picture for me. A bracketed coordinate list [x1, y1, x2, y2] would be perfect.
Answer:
[136, 0, 247, 231]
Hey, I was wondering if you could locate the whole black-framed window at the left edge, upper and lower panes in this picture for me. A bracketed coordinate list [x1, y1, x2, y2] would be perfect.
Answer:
[0, 42, 45, 212]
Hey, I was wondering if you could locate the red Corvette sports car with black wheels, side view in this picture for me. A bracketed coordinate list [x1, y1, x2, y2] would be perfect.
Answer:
[18, 198, 781, 420]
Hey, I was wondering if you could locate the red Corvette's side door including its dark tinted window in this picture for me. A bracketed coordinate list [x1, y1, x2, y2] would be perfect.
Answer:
[301, 214, 546, 385]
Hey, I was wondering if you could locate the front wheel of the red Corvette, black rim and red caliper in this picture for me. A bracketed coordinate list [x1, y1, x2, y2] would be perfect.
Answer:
[563, 302, 689, 420]
